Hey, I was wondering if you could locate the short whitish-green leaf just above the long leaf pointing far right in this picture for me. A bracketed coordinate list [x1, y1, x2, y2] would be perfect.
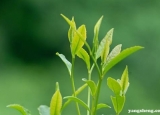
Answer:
[105, 44, 122, 64]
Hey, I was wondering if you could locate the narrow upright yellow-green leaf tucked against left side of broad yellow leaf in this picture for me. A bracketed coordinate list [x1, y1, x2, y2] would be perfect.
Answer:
[68, 18, 76, 43]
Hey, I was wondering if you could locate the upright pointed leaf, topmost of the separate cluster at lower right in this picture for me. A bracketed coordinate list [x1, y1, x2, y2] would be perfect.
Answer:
[120, 66, 129, 95]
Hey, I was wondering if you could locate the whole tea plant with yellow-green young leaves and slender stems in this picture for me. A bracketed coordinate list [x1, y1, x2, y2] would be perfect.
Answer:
[7, 14, 143, 115]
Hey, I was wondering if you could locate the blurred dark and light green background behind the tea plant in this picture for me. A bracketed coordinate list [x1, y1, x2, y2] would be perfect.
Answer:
[0, 0, 160, 115]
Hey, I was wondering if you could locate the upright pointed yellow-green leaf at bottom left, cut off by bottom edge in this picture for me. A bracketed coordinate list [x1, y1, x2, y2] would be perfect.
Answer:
[50, 83, 62, 115]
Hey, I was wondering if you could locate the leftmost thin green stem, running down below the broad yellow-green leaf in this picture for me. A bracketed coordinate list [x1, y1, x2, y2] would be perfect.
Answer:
[71, 57, 81, 115]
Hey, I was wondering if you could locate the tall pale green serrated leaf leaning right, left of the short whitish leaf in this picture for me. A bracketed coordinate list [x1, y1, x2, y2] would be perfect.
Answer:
[96, 28, 113, 59]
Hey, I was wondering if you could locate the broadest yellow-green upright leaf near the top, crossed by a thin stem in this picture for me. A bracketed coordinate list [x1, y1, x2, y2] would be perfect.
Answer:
[71, 25, 86, 56]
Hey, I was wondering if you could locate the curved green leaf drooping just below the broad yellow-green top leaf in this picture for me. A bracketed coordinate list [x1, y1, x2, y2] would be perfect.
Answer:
[77, 48, 90, 70]
